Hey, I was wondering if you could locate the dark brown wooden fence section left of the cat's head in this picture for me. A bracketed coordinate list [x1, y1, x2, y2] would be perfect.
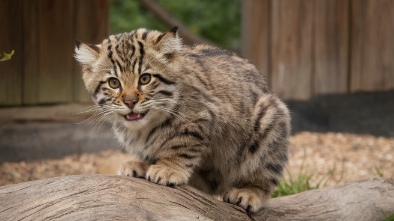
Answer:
[0, 0, 109, 105]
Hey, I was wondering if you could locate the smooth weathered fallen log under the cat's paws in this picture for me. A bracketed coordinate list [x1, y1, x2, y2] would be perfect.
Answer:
[0, 175, 394, 221]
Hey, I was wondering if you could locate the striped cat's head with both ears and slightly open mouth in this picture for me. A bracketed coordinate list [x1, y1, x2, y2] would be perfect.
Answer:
[75, 27, 182, 128]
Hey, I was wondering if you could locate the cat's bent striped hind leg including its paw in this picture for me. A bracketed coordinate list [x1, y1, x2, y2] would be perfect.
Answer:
[223, 94, 290, 213]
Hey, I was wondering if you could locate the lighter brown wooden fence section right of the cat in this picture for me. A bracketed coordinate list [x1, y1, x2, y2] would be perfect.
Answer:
[242, 0, 394, 99]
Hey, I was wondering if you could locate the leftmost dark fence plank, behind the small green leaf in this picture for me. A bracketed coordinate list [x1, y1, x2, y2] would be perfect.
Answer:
[0, 0, 24, 106]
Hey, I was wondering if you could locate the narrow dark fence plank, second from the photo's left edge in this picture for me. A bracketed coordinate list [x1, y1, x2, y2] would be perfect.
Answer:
[23, 0, 40, 104]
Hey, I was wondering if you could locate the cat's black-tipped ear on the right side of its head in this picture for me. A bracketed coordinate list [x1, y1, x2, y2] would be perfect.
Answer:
[155, 26, 182, 56]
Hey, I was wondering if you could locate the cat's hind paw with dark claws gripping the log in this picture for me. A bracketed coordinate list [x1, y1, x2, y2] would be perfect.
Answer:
[223, 187, 268, 213]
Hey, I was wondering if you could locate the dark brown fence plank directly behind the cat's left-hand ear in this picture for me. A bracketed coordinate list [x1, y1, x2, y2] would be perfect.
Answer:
[73, 0, 109, 101]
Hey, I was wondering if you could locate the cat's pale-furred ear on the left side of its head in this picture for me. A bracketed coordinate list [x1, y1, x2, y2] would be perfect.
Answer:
[75, 40, 101, 65]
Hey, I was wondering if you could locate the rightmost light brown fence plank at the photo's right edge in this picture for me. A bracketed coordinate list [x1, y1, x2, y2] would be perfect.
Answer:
[350, 0, 394, 91]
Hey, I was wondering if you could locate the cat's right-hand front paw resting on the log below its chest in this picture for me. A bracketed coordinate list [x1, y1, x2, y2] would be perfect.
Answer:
[146, 164, 190, 186]
